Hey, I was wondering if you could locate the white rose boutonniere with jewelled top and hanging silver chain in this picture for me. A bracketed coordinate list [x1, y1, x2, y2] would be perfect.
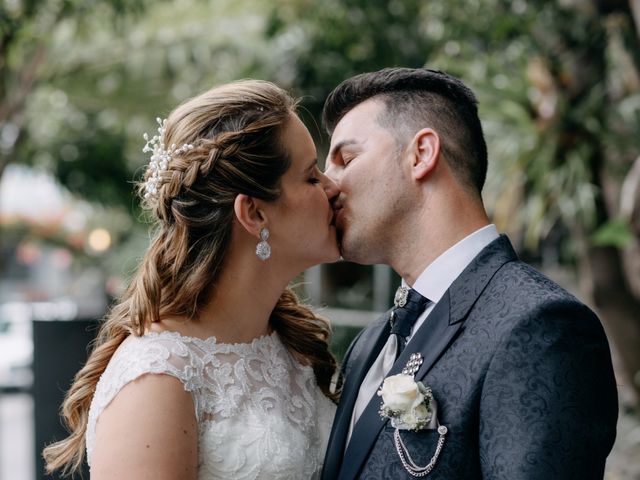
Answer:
[378, 353, 448, 477]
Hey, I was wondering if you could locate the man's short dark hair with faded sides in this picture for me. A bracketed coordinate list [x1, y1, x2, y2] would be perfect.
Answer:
[322, 68, 487, 194]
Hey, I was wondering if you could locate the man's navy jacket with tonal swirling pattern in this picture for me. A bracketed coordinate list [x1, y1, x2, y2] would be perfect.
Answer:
[322, 236, 618, 480]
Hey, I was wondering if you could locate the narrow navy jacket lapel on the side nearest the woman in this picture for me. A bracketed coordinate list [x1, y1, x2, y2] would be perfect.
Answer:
[322, 312, 390, 480]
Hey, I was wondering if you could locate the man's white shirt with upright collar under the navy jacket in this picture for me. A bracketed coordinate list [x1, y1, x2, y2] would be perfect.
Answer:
[345, 224, 499, 449]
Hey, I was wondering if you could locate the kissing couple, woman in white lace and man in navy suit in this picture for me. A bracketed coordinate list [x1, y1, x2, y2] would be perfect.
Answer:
[44, 68, 617, 480]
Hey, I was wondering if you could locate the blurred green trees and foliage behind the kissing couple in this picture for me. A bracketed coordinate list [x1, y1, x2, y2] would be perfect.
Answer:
[0, 0, 640, 394]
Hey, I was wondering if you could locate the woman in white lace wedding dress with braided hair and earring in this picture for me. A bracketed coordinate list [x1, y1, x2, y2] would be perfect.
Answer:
[44, 80, 339, 480]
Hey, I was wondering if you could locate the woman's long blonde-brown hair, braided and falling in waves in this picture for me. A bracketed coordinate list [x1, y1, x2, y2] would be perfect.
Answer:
[43, 80, 336, 474]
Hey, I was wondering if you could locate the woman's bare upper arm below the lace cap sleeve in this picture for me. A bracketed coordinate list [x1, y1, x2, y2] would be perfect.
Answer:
[91, 374, 198, 480]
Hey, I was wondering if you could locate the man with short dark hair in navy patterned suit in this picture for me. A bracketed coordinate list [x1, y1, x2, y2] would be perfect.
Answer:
[322, 68, 617, 480]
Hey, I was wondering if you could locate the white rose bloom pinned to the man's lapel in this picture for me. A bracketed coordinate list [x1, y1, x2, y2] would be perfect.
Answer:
[378, 373, 433, 430]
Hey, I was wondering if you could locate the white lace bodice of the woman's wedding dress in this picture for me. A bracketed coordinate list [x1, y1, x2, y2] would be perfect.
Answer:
[86, 332, 335, 480]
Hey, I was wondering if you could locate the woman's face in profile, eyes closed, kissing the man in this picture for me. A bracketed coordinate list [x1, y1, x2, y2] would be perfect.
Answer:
[268, 115, 340, 271]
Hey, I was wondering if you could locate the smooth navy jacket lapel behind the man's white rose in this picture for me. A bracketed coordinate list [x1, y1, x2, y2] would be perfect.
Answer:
[338, 235, 517, 480]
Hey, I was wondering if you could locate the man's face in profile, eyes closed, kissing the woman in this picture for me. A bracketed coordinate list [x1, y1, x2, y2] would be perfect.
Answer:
[325, 98, 408, 264]
